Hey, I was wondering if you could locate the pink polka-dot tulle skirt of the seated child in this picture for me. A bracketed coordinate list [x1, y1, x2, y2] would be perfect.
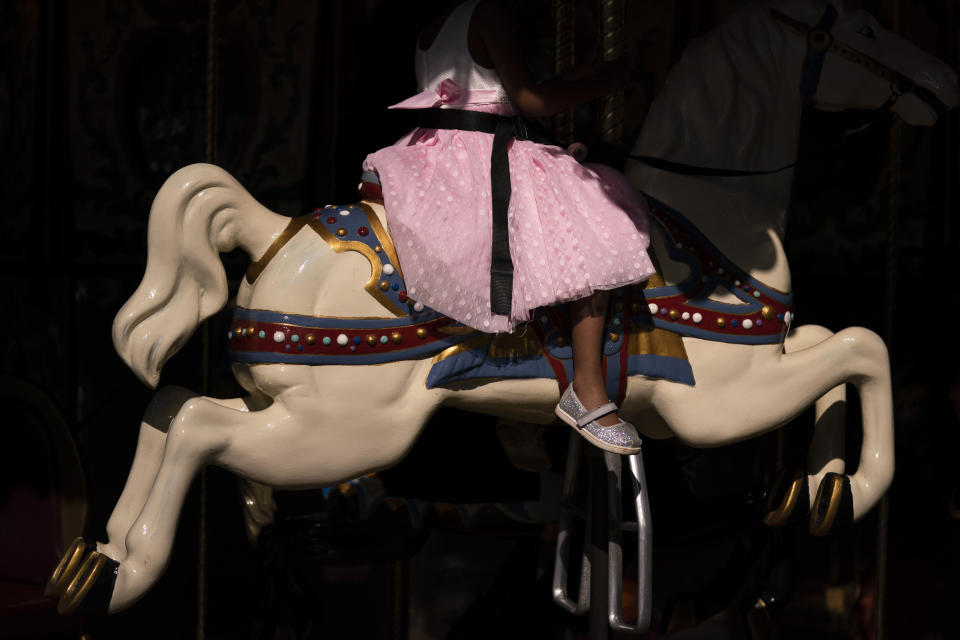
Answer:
[364, 129, 654, 332]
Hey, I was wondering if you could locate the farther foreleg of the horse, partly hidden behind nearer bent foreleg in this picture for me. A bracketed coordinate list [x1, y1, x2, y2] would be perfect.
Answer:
[764, 325, 847, 527]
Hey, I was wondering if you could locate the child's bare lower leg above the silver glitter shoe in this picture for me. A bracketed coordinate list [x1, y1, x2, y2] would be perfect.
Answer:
[570, 291, 620, 427]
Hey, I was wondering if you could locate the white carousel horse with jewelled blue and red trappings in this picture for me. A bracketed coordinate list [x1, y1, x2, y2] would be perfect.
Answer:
[48, 0, 957, 613]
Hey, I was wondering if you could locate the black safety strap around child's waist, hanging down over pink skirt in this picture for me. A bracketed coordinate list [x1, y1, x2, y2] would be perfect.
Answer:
[417, 109, 525, 315]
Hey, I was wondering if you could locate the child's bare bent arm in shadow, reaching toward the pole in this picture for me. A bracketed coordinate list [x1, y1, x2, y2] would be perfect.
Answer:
[471, 0, 628, 118]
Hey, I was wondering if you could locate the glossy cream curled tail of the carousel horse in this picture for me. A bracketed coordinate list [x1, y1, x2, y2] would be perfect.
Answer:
[113, 164, 280, 387]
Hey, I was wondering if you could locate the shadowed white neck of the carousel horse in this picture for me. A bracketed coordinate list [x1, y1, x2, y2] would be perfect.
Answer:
[628, 6, 802, 287]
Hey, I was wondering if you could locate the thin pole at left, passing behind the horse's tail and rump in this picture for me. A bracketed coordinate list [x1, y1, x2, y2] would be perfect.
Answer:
[196, 0, 219, 640]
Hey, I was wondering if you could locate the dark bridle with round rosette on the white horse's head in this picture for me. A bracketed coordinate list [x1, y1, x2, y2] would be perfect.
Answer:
[770, 4, 947, 112]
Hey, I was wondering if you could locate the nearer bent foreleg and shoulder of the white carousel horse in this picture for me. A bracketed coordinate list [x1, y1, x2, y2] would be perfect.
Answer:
[653, 327, 894, 534]
